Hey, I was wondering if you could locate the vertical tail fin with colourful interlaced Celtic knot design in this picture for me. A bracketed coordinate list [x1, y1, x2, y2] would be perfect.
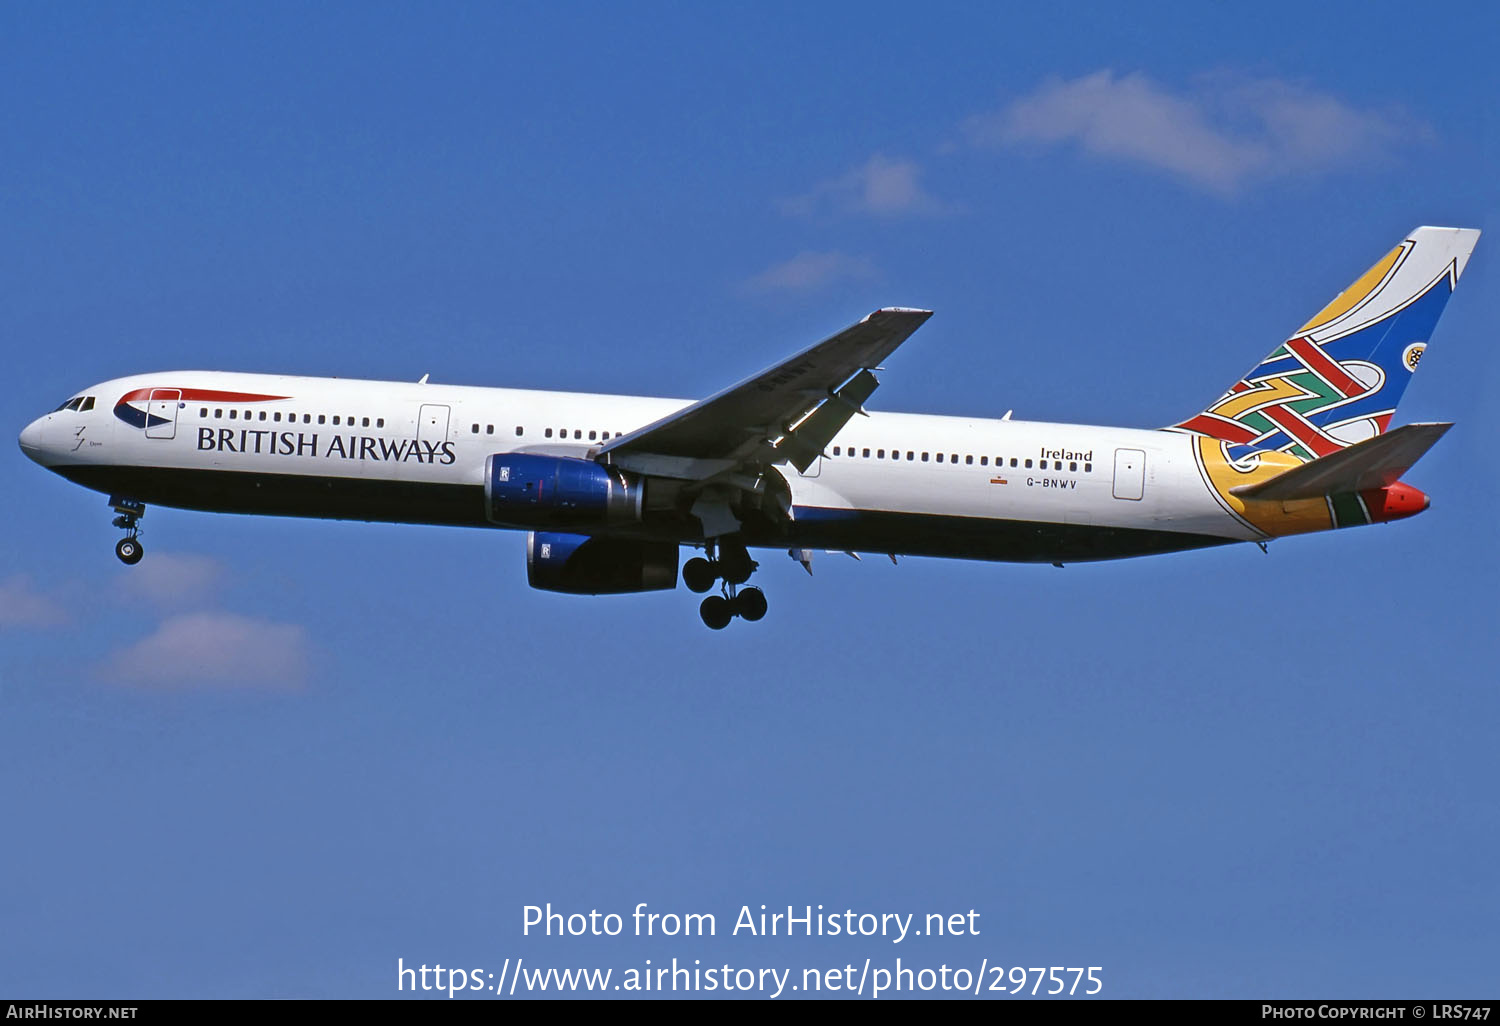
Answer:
[1175, 228, 1479, 461]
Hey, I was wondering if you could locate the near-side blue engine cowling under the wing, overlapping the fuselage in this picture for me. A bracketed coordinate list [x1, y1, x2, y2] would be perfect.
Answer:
[485, 453, 642, 527]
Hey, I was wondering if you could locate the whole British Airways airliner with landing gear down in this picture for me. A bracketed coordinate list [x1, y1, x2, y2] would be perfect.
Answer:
[20, 227, 1479, 630]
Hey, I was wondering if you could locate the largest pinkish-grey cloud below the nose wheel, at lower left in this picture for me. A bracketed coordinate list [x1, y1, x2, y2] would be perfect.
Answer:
[101, 612, 308, 687]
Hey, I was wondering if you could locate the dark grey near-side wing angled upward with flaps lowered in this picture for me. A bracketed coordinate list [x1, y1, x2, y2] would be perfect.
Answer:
[596, 308, 932, 482]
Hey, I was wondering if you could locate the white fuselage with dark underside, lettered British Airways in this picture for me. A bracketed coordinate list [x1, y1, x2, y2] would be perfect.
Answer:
[21, 371, 1265, 561]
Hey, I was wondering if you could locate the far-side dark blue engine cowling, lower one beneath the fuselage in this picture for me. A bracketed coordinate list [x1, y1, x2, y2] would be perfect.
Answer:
[527, 531, 677, 596]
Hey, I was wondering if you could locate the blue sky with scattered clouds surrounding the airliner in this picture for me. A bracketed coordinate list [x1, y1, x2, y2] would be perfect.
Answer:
[0, 3, 1500, 998]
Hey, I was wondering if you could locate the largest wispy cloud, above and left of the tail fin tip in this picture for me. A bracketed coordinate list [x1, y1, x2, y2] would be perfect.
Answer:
[963, 69, 1431, 194]
